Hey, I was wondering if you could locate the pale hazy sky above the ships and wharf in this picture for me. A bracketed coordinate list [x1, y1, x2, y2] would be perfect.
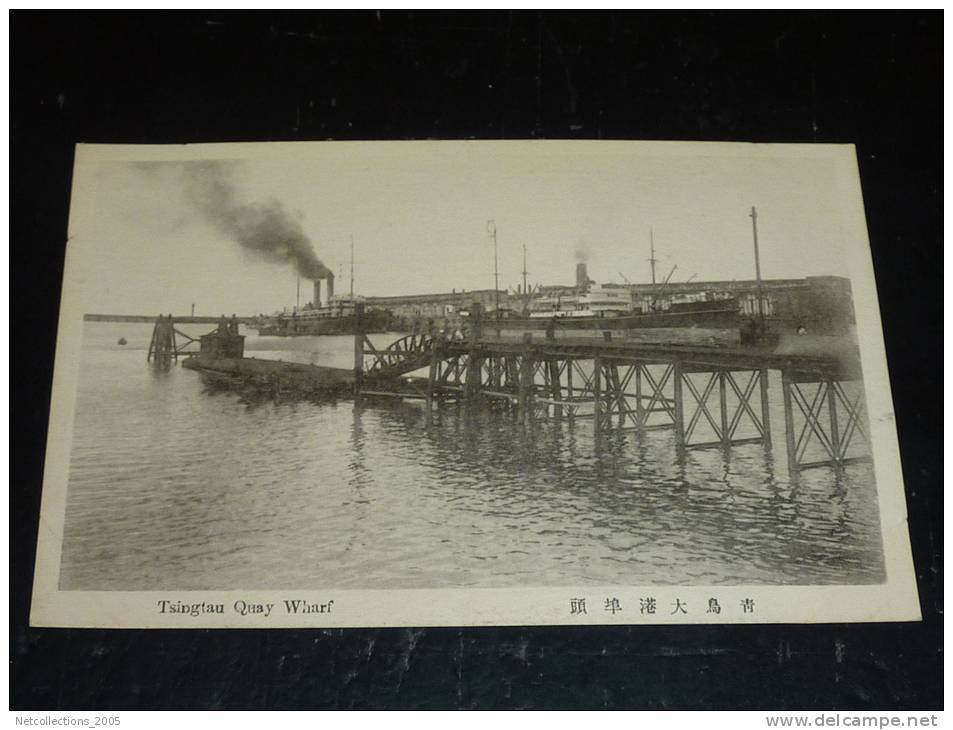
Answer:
[68, 142, 847, 314]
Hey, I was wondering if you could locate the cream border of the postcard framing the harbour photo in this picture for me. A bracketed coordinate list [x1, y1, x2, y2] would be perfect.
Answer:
[30, 141, 921, 628]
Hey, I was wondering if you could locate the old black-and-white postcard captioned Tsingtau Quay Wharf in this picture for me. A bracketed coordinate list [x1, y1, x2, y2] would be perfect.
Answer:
[31, 141, 920, 628]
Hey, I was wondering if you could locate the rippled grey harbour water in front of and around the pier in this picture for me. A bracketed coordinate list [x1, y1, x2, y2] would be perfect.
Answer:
[60, 322, 884, 591]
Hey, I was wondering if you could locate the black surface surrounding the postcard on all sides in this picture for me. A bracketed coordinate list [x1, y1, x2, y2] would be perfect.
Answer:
[10, 12, 942, 709]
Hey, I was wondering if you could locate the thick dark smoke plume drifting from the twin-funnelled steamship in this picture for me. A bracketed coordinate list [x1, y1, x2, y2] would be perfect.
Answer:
[186, 161, 333, 279]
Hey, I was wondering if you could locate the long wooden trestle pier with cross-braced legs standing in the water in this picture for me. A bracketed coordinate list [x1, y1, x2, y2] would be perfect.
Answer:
[354, 305, 870, 479]
